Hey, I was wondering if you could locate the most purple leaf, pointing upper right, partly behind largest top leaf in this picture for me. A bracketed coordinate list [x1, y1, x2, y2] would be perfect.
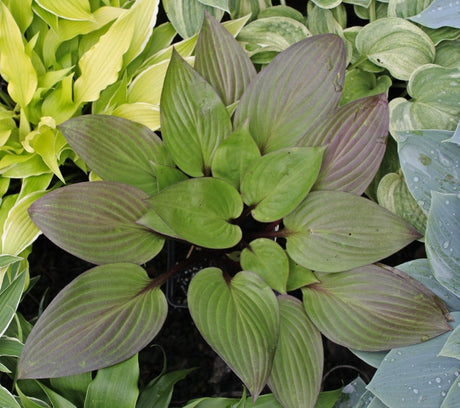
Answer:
[299, 94, 389, 195]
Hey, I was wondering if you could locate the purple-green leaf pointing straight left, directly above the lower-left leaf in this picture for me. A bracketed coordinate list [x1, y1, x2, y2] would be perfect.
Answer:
[29, 181, 164, 264]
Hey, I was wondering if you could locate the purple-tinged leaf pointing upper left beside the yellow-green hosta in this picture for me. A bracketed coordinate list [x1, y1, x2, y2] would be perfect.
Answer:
[59, 115, 175, 194]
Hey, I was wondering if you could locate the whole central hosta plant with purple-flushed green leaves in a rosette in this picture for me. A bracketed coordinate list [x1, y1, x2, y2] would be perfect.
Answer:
[18, 15, 450, 407]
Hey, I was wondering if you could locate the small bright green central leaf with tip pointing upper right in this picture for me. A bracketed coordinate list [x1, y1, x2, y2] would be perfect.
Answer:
[241, 147, 324, 222]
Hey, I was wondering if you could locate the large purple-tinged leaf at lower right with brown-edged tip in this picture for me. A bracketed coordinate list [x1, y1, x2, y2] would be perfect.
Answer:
[302, 264, 450, 351]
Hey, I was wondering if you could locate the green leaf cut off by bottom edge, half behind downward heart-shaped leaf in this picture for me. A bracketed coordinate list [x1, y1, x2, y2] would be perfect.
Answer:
[268, 296, 324, 408]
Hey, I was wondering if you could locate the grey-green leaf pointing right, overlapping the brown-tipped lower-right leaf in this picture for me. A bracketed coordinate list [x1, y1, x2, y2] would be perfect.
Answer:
[284, 191, 420, 272]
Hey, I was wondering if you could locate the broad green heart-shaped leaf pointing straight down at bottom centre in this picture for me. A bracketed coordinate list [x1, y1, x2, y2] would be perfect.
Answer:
[187, 268, 280, 400]
